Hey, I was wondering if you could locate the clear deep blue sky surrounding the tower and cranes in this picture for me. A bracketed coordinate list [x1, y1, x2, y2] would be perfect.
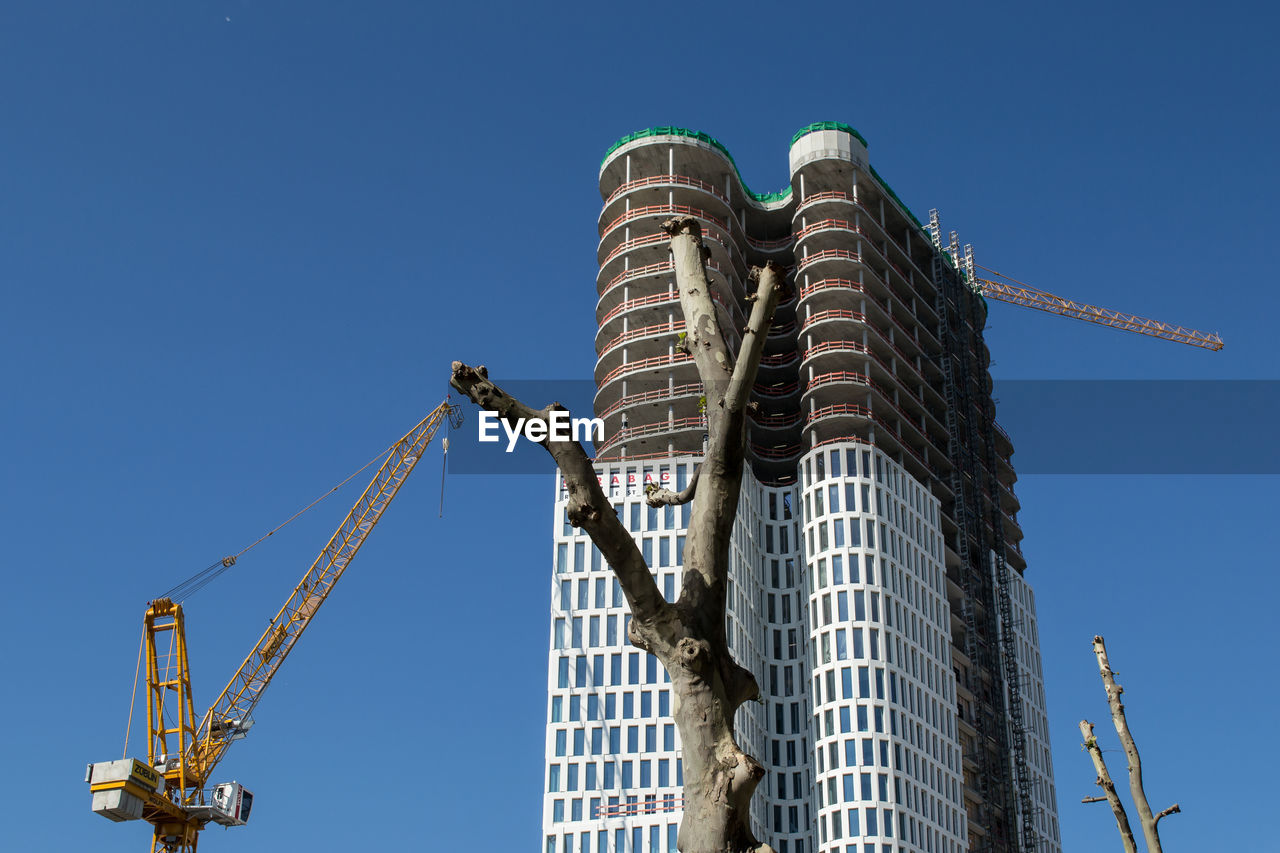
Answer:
[0, 0, 1280, 853]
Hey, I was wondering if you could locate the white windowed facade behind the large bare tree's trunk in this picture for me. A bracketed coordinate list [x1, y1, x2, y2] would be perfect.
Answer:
[543, 457, 767, 853]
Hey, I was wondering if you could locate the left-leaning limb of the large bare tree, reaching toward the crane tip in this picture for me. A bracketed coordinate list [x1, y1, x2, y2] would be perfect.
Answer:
[449, 361, 669, 637]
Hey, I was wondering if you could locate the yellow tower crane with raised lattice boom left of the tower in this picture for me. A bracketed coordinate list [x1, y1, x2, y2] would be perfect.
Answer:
[84, 400, 461, 853]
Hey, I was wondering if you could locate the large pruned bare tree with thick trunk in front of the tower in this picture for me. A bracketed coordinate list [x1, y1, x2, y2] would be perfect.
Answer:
[449, 218, 785, 853]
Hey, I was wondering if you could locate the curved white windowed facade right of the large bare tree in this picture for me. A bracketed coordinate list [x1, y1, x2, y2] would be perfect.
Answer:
[800, 443, 966, 853]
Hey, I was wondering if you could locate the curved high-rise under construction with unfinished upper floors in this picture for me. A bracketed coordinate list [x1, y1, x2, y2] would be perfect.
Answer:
[543, 123, 1061, 853]
